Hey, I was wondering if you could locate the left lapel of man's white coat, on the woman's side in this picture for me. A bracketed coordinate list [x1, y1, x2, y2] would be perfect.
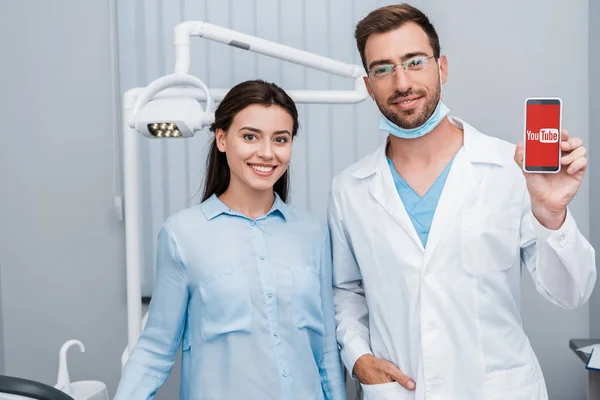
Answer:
[369, 152, 425, 251]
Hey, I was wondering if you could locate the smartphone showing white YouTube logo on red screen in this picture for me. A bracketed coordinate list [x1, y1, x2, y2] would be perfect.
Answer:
[523, 97, 562, 174]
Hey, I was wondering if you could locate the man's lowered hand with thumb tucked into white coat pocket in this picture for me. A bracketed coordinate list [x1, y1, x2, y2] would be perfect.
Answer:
[352, 354, 416, 390]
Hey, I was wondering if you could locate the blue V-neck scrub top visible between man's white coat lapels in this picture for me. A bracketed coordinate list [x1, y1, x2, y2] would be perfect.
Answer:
[387, 157, 454, 247]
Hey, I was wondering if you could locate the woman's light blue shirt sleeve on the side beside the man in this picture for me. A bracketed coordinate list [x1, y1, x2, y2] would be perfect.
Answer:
[319, 229, 346, 400]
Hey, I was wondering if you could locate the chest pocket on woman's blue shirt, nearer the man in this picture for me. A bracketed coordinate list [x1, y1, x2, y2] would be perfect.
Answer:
[289, 265, 324, 335]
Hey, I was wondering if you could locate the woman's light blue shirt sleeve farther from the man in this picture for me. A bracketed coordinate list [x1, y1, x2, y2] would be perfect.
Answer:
[114, 227, 188, 400]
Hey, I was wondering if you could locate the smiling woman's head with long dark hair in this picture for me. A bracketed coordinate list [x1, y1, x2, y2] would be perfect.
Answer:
[203, 80, 298, 209]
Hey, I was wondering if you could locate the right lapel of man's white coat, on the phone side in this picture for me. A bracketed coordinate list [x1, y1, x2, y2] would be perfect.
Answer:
[424, 150, 483, 265]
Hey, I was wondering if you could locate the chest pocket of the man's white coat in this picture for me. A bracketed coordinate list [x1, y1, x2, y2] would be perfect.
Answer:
[461, 209, 521, 275]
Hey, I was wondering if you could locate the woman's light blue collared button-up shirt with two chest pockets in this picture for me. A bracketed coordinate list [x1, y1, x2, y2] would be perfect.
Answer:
[115, 196, 346, 400]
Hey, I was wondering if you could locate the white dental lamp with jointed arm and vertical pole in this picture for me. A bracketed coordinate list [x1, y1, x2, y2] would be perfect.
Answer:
[120, 21, 368, 366]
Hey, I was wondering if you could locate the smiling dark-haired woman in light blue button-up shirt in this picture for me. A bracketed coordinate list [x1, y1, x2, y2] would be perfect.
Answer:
[115, 80, 346, 400]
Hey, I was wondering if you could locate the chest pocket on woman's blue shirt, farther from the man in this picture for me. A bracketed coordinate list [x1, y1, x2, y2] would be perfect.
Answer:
[197, 267, 252, 342]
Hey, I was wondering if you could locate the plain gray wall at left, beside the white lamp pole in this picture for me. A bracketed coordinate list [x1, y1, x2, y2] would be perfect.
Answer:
[0, 0, 127, 393]
